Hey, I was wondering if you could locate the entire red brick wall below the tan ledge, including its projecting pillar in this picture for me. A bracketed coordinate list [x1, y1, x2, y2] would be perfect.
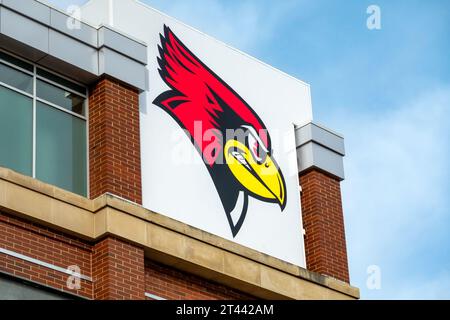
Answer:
[0, 212, 253, 300]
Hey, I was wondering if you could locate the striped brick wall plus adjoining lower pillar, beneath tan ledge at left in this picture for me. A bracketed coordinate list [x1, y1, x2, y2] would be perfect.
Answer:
[0, 213, 145, 300]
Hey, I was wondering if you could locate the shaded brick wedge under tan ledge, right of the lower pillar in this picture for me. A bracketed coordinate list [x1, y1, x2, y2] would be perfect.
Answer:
[145, 261, 253, 300]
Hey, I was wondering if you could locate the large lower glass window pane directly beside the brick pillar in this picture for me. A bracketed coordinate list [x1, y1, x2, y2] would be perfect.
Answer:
[36, 102, 87, 196]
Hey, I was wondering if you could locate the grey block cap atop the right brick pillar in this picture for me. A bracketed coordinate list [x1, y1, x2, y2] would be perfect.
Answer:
[295, 123, 345, 180]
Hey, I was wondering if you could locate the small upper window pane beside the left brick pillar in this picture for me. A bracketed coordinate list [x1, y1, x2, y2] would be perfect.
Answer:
[36, 79, 85, 116]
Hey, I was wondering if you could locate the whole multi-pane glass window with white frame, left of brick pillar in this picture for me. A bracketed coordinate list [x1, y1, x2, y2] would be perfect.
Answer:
[0, 51, 87, 196]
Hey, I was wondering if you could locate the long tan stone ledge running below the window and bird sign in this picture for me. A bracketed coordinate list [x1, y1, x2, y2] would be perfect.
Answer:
[0, 168, 359, 299]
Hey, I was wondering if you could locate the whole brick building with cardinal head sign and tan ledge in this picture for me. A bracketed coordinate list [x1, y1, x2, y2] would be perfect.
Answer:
[0, 0, 359, 300]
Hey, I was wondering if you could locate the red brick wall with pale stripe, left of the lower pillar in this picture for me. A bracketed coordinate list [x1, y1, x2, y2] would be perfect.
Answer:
[0, 212, 93, 298]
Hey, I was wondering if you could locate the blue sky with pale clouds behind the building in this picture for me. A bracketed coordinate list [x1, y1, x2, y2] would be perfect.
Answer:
[46, 0, 450, 299]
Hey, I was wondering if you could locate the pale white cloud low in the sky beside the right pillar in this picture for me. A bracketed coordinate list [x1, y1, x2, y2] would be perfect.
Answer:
[337, 88, 450, 298]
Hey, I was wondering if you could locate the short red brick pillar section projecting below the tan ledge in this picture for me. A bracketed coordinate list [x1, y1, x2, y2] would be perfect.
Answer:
[92, 237, 145, 300]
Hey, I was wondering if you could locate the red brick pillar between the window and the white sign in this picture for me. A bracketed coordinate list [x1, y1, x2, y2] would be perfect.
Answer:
[89, 78, 142, 204]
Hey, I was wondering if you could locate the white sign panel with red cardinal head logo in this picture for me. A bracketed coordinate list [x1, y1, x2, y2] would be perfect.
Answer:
[83, 0, 312, 267]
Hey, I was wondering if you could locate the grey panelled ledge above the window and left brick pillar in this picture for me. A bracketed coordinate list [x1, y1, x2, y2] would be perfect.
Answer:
[0, 0, 148, 91]
